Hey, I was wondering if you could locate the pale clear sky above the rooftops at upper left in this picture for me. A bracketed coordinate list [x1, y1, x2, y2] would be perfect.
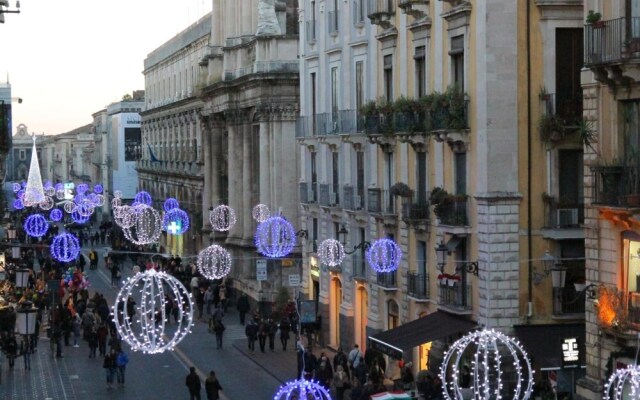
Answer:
[0, 0, 212, 135]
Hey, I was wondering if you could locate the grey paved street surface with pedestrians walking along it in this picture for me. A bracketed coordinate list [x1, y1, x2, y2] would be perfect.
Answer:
[0, 249, 304, 400]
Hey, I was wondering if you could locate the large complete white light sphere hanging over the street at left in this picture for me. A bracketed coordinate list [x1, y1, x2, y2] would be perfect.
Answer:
[112, 269, 193, 354]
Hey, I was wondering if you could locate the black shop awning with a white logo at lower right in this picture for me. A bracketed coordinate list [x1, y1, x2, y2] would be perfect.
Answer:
[514, 323, 586, 370]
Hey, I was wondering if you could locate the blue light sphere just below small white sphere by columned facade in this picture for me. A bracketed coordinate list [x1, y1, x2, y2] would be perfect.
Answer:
[255, 217, 296, 258]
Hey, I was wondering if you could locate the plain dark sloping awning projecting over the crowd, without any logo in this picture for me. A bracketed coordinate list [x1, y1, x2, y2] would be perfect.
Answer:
[367, 311, 477, 360]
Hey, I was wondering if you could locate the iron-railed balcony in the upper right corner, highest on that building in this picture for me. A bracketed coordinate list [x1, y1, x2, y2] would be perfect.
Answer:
[584, 17, 640, 85]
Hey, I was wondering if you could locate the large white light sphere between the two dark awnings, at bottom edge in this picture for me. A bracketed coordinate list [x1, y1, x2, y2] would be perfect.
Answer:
[440, 329, 533, 400]
